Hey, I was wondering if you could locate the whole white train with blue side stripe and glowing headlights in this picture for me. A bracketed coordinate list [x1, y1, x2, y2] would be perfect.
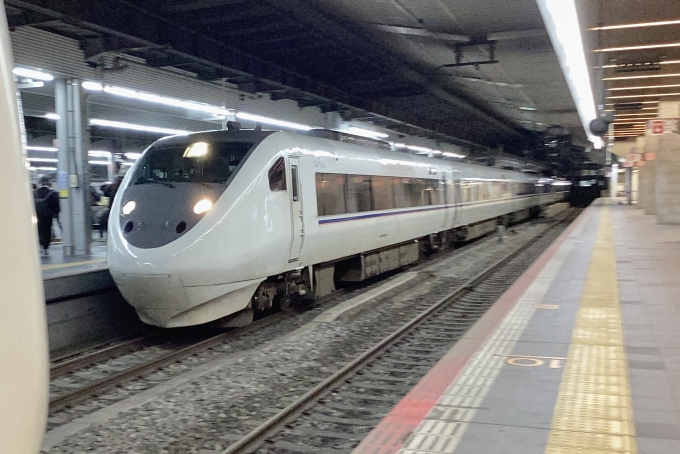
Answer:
[108, 130, 563, 327]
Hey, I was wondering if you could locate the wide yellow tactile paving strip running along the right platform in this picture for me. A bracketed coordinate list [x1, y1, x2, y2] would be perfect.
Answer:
[545, 207, 637, 454]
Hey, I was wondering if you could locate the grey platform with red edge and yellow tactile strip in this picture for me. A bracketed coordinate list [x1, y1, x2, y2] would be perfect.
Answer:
[353, 199, 680, 454]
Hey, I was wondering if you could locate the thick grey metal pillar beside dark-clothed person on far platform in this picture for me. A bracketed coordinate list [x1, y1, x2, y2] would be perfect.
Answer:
[55, 79, 92, 256]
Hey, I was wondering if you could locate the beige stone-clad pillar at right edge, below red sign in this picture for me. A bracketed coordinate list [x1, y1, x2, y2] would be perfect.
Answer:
[655, 134, 680, 224]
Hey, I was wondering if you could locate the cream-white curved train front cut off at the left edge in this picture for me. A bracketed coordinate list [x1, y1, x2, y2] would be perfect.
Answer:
[0, 4, 49, 454]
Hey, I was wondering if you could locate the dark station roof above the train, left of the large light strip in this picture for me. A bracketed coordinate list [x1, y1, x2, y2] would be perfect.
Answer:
[5, 0, 672, 148]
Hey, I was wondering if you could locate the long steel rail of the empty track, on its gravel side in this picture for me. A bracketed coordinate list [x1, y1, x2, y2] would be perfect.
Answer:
[221, 210, 577, 454]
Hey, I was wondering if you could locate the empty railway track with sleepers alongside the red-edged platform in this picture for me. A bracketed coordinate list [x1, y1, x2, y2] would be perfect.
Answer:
[222, 210, 580, 454]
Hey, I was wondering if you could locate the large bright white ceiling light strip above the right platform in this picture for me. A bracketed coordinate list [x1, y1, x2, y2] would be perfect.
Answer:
[537, 0, 603, 148]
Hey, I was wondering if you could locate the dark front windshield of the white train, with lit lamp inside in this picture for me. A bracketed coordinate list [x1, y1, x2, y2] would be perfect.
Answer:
[132, 141, 254, 186]
